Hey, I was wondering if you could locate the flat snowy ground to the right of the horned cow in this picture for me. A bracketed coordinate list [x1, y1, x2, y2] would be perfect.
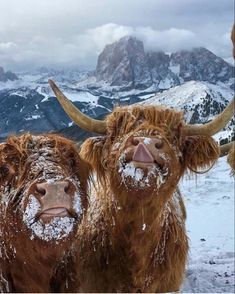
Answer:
[180, 157, 235, 293]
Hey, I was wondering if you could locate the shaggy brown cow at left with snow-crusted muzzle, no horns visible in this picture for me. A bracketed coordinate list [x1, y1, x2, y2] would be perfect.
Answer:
[0, 134, 90, 292]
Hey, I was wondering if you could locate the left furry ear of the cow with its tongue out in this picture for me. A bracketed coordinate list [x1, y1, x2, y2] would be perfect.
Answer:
[80, 136, 106, 173]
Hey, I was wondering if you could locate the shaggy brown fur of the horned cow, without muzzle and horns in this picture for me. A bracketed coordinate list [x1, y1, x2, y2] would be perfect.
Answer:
[77, 106, 219, 292]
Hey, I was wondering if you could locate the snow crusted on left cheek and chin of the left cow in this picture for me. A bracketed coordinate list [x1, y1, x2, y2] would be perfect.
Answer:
[23, 195, 75, 241]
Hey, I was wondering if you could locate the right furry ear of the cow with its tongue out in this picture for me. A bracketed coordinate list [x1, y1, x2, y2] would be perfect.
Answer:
[183, 136, 220, 172]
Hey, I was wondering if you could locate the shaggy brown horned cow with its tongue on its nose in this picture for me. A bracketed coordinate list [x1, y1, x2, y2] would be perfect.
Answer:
[50, 81, 234, 292]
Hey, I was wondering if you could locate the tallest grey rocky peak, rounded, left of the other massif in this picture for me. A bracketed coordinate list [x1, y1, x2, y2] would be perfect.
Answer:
[96, 37, 151, 88]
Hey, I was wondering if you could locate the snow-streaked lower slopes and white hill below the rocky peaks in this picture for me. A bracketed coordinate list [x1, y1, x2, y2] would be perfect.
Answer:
[0, 75, 233, 139]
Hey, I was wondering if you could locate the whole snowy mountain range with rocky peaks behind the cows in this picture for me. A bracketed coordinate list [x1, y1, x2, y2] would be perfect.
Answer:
[0, 37, 234, 137]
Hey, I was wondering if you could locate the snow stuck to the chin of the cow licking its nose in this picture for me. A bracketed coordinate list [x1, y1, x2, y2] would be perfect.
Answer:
[118, 153, 168, 188]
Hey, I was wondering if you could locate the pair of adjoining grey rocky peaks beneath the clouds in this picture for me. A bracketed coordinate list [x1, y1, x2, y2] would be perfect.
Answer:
[96, 37, 234, 90]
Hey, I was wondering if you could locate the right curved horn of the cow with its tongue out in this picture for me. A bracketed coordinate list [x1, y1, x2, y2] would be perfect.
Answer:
[182, 96, 235, 136]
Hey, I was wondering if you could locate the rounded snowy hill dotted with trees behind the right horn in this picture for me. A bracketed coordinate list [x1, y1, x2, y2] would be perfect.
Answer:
[142, 81, 234, 141]
